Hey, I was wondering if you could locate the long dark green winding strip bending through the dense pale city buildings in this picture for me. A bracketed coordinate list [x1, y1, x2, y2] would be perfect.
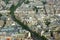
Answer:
[2, 0, 47, 40]
